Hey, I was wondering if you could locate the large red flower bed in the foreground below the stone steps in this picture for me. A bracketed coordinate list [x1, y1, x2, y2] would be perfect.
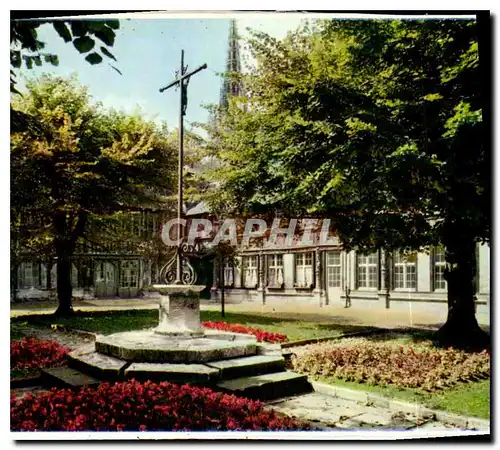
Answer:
[10, 380, 304, 431]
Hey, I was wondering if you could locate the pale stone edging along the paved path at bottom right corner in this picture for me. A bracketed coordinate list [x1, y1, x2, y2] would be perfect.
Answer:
[309, 380, 491, 429]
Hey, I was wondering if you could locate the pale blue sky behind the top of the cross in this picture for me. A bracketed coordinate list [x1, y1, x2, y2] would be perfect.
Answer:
[16, 15, 303, 134]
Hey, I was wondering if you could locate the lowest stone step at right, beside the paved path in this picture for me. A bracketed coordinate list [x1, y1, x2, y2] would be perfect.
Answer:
[216, 372, 312, 400]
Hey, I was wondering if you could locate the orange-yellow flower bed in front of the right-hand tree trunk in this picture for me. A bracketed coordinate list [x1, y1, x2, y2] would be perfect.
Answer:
[291, 340, 490, 391]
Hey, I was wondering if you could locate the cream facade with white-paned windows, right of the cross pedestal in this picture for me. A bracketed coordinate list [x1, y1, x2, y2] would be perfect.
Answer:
[212, 242, 490, 308]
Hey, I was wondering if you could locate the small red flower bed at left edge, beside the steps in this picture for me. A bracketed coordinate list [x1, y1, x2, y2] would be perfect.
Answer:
[10, 337, 69, 374]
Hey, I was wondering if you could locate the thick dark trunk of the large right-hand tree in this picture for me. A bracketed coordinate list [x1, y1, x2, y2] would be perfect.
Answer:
[436, 235, 490, 349]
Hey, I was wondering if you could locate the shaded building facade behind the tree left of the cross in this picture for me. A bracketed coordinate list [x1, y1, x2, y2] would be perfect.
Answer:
[11, 210, 166, 301]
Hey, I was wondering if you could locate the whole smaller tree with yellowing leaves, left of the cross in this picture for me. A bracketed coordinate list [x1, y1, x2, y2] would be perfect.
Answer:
[11, 76, 176, 314]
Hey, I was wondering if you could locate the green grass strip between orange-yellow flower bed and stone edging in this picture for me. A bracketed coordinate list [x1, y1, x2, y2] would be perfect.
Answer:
[317, 377, 490, 419]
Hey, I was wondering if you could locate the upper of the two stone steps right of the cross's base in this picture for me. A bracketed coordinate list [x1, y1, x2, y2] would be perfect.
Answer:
[205, 356, 285, 380]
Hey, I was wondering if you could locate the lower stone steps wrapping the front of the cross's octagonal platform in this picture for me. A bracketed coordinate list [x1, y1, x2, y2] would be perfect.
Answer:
[52, 344, 312, 400]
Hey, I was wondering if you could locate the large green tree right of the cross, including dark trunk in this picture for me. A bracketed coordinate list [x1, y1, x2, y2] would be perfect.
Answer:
[205, 20, 491, 345]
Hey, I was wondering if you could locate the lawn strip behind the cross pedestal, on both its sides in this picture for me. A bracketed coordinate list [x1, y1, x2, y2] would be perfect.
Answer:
[13, 310, 373, 341]
